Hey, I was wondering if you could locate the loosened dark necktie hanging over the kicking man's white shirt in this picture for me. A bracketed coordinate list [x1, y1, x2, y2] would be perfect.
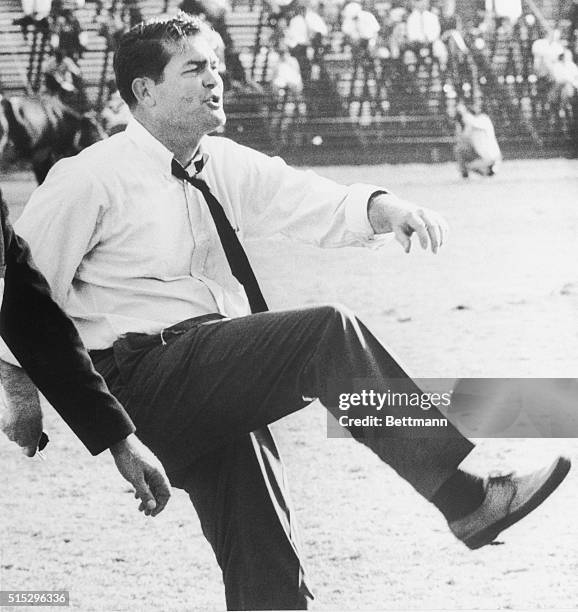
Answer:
[171, 159, 269, 312]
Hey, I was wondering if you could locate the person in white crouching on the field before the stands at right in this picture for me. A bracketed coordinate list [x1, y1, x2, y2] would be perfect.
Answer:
[455, 102, 502, 178]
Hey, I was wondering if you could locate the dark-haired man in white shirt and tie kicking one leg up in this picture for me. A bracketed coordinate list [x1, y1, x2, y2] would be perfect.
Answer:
[4, 15, 569, 609]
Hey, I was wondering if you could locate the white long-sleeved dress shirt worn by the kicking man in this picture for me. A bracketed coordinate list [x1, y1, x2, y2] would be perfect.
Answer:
[0, 118, 388, 358]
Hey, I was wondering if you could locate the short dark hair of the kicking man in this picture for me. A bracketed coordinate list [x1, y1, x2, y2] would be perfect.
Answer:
[114, 11, 210, 108]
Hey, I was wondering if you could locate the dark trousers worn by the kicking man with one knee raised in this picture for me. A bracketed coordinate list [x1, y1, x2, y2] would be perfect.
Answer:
[90, 306, 473, 609]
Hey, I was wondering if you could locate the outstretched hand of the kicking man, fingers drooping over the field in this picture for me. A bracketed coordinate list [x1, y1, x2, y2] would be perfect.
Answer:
[367, 193, 448, 253]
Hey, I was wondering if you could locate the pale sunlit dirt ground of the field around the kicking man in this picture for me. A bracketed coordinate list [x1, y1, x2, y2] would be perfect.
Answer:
[0, 160, 578, 612]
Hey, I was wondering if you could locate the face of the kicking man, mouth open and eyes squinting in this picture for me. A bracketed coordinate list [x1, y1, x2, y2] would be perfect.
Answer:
[148, 35, 225, 137]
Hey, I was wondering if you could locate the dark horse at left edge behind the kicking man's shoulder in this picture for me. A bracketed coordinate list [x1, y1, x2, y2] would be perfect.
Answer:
[0, 96, 106, 184]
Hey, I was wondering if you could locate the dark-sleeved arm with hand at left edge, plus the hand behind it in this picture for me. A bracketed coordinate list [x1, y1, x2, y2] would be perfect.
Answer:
[0, 192, 170, 516]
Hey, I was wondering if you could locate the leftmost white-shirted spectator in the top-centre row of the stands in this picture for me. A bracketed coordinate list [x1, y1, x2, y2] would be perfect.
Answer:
[283, 3, 329, 83]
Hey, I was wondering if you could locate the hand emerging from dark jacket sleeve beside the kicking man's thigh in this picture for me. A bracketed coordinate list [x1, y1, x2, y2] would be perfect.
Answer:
[110, 434, 171, 516]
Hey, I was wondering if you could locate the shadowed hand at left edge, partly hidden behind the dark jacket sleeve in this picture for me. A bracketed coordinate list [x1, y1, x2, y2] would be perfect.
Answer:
[0, 360, 42, 457]
